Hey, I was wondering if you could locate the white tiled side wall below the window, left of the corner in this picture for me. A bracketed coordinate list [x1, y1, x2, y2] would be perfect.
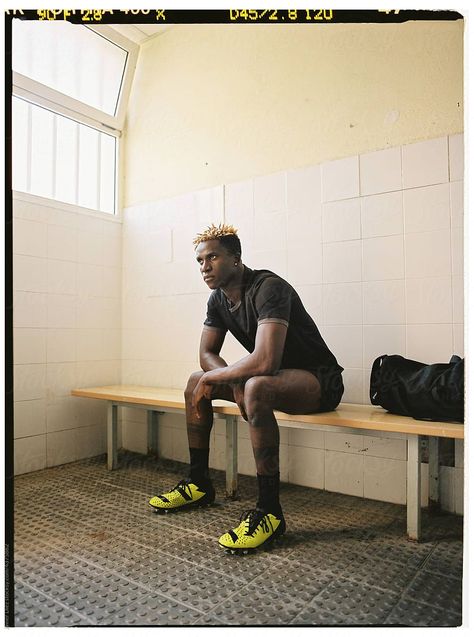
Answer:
[13, 194, 122, 474]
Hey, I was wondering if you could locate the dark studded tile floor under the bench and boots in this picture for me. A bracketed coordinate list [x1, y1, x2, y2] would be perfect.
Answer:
[14, 453, 463, 626]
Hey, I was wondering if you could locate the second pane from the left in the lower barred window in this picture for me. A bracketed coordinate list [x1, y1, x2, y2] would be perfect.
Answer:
[30, 103, 54, 197]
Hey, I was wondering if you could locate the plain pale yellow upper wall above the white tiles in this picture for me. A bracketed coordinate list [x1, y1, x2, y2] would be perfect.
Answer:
[123, 21, 463, 206]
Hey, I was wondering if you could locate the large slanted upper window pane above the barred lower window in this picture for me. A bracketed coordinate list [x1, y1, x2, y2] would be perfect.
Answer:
[12, 19, 127, 115]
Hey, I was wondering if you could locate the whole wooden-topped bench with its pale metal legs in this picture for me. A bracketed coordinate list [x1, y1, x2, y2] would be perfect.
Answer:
[71, 385, 464, 540]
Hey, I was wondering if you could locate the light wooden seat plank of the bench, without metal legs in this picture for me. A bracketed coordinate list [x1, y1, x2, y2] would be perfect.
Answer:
[71, 385, 464, 439]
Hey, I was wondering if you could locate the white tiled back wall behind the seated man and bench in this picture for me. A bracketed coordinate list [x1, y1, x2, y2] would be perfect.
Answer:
[122, 135, 463, 512]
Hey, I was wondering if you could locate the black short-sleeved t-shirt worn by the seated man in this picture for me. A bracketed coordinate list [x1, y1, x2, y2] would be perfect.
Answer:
[204, 266, 343, 373]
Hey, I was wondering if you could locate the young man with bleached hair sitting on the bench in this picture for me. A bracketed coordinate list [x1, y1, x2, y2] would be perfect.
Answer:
[150, 224, 344, 552]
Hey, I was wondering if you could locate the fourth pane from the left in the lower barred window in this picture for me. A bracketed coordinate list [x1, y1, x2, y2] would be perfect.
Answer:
[77, 126, 99, 210]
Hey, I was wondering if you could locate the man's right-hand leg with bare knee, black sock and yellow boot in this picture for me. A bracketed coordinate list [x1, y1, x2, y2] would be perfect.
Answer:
[219, 369, 321, 552]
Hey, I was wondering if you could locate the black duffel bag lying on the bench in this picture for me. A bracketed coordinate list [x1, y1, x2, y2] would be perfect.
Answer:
[370, 354, 464, 422]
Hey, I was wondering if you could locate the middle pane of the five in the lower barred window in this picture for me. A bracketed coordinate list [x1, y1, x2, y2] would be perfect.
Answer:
[54, 115, 79, 203]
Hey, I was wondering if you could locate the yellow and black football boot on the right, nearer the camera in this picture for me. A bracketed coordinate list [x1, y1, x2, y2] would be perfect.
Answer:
[219, 509, 286, 554]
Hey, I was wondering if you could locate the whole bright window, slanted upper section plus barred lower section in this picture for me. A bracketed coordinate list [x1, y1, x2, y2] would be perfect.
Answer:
[12, 19, 138, 213]
